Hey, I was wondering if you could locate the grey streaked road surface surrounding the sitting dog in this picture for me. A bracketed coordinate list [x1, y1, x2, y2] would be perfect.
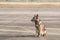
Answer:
[0, 8, 60, 40]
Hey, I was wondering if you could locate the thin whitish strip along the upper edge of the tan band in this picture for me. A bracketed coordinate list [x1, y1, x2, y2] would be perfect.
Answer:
[0, 2, 60, 5]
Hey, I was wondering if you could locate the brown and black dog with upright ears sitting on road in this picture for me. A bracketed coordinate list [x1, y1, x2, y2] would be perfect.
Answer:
[31, 14, 47, 37]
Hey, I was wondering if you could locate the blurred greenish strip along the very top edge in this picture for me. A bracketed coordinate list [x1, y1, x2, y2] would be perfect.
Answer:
[0, 0, 60, 2]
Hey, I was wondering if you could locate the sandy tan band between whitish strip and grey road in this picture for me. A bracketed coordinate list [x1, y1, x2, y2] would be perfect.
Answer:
[0, 4, 60, 8]
